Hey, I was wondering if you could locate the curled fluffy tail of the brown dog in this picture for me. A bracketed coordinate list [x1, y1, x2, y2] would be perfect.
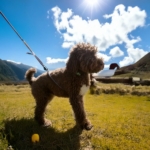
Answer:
[25, 68, 36, 85]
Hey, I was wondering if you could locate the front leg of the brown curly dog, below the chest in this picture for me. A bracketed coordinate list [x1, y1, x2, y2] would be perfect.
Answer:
[70, 95, 93, 130]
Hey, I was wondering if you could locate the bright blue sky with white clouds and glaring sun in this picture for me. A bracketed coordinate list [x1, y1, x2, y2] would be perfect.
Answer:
[0, 0, 150, 70]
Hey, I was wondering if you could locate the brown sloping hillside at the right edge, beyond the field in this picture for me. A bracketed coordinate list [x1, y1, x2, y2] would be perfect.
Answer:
[115, 53, 150, 78]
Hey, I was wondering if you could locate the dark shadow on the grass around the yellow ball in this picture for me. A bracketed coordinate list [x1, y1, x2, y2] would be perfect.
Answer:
[4, 119, 82, 150]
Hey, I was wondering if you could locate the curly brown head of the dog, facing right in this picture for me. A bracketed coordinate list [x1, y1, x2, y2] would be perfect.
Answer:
[66, 43, 104, 73]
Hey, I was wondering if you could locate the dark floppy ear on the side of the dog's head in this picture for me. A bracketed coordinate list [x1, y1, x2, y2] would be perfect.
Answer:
[66, 51, 78, 74]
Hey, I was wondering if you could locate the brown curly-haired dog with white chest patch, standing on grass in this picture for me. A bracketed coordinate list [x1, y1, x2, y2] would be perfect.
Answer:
[25, 43, 104, 130]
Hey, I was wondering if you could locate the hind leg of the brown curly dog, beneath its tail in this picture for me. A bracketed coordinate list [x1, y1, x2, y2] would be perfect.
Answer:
[34, 95, 53, 127]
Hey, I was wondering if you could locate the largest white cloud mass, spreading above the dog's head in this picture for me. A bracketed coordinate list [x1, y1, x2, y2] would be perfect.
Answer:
[52, 5, 146, 51]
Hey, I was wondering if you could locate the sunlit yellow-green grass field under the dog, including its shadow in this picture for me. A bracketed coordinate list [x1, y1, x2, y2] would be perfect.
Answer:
[0, 85, 150, 150]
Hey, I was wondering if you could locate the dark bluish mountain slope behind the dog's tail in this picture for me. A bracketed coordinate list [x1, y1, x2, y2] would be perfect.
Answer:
[0, 59, 44, 81]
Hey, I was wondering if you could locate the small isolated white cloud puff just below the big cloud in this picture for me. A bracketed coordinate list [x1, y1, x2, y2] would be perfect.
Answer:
[109, 46, 124, 57]
